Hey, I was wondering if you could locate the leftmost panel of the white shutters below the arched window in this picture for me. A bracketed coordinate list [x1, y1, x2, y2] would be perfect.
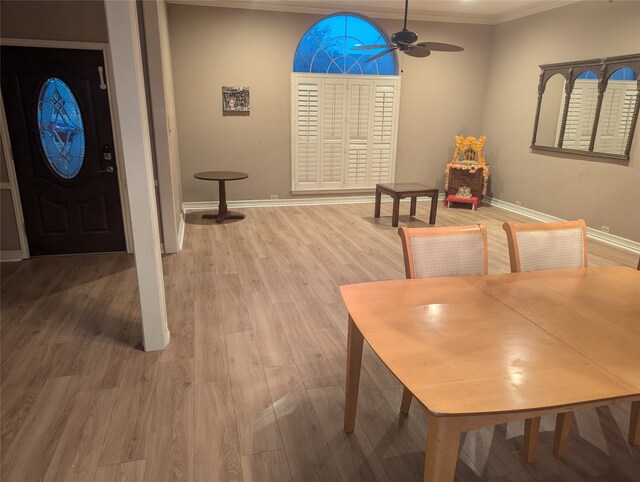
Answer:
[294, 82, 319, 187]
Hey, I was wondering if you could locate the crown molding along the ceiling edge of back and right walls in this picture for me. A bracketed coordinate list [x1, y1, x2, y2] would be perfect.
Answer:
[167, 0, 582, 25]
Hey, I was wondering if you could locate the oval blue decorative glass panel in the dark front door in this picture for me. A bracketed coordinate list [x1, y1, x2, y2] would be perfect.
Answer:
[38, 77, 85, 179]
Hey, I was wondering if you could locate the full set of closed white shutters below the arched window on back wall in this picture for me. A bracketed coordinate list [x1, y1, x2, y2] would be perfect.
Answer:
[292, 73, 400, 191]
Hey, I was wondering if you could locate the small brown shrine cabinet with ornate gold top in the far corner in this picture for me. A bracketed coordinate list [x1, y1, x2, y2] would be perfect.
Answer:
[444, 136, 489, 200]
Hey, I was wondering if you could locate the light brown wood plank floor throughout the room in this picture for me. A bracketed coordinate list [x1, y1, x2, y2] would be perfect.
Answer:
[0, 202, 640, 482]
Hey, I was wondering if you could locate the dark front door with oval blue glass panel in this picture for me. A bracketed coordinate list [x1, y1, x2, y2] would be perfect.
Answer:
[0, 46, 125, 256]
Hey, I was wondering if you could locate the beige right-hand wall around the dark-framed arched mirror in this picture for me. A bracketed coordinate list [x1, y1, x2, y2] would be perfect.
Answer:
[482, 0, 640, 241]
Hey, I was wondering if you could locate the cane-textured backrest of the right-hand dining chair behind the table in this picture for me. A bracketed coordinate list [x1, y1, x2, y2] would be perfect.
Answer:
[502, 219, 587, 273]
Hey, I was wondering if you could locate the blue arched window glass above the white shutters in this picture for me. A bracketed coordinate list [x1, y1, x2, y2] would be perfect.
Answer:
[293, 13, 398, 75]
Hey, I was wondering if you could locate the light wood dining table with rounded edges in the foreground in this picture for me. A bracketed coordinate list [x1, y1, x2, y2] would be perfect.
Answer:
[340, 267, 640, 482]
